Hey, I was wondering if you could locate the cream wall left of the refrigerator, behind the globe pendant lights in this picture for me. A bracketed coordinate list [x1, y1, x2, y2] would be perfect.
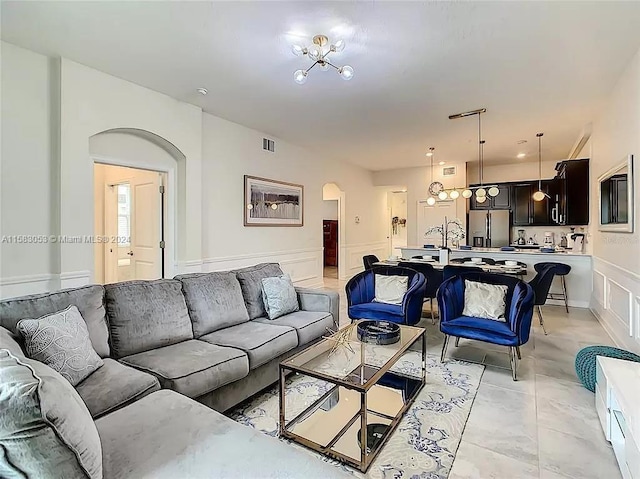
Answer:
[373, 165, 467, 246]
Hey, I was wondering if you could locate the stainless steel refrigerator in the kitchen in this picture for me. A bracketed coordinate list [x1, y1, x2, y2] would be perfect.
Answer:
[467, 210, 511, 248]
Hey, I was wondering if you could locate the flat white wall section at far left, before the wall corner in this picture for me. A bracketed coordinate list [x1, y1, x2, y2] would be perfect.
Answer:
[0, 42, 60, 294]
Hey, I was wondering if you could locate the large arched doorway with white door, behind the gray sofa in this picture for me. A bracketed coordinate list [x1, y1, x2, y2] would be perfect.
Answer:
[89, 128, 186, 282]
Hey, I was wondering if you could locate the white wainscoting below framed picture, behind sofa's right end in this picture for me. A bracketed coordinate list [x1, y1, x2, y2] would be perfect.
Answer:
[202, 248, 323, 288]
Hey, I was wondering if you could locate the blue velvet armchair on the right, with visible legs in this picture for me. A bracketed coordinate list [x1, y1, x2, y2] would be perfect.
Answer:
[438, 272, 534, 381]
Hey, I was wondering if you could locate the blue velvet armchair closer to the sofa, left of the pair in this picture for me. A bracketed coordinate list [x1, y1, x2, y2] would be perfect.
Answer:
[345, 266, 426, 325]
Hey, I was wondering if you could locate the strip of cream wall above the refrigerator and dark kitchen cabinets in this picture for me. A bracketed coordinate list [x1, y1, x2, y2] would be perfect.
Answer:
[467, 158, 560, 184]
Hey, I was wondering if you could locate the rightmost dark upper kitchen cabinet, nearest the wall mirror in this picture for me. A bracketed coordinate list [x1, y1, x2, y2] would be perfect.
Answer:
[556, 158, 589, 225]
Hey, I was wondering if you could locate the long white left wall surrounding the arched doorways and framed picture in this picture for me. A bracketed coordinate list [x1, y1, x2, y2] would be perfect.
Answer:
[0, 43, 388, 297]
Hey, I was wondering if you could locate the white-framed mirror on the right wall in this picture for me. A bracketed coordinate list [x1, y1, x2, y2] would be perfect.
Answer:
[598, 155, 634, 233]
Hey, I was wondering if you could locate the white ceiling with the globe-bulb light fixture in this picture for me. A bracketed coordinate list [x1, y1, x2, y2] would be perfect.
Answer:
[1, 1, 640, 170]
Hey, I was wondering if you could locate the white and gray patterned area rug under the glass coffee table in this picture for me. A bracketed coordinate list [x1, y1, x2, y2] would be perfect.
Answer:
[228, 351, 484, 479]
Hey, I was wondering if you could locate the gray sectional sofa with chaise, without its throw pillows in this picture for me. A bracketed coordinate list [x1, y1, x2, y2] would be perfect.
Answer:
[0, 263, 350, 478]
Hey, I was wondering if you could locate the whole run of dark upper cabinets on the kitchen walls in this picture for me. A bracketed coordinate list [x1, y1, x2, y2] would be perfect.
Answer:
[469, 159, 589, 226]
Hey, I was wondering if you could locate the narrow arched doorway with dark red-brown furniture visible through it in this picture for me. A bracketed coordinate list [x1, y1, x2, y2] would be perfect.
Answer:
[322, 183, 346, 282]
